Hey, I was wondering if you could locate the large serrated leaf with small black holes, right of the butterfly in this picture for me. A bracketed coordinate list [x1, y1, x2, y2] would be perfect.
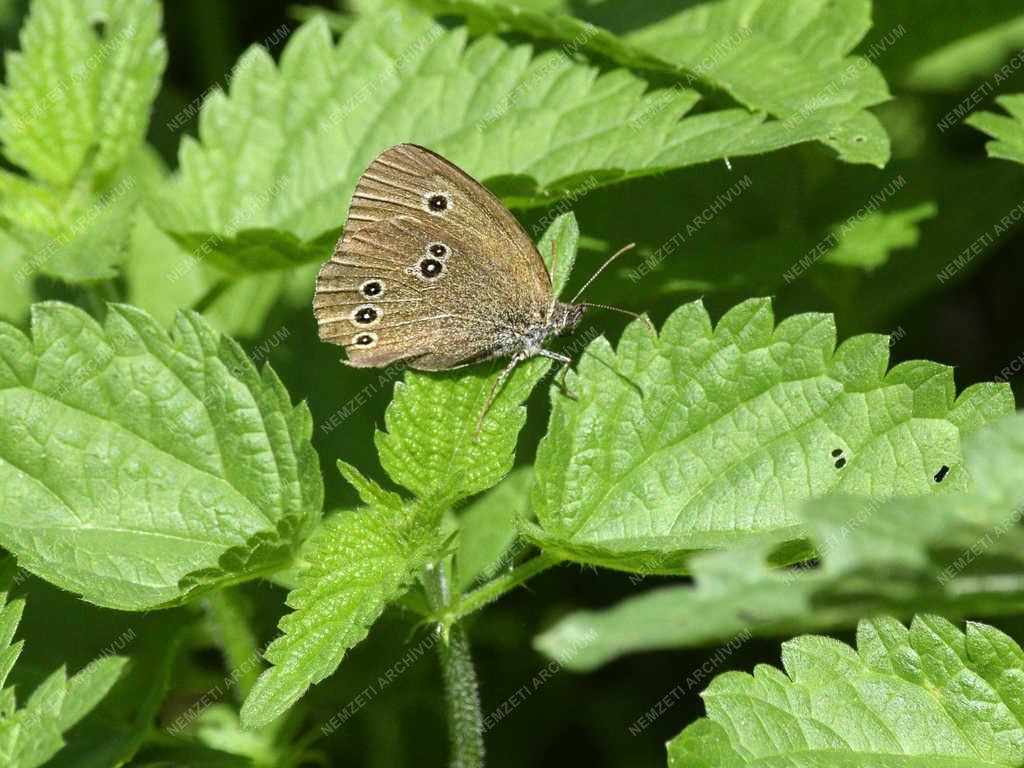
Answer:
[530, 299, 1013, 572]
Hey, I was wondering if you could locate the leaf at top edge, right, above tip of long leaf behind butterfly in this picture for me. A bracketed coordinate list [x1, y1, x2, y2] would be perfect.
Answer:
[625, 0, 890, 167]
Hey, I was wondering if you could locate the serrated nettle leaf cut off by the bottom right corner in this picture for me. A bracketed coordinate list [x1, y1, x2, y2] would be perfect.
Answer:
[669, 615, 1024, 768]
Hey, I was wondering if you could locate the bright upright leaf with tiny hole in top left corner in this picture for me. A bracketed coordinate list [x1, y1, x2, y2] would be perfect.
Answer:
[0, 0, 167, 187]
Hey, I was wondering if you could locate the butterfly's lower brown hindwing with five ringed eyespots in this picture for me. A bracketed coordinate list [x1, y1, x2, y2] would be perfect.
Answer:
[313, 216, 542, 371]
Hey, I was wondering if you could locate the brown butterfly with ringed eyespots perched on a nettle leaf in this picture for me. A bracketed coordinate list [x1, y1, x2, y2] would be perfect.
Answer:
[313, 144, 646, 429]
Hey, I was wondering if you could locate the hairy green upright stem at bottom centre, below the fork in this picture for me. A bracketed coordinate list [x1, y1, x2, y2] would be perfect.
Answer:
[439, 624, 483, 768]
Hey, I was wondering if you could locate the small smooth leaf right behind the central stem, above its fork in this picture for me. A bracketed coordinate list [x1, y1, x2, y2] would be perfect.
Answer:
[458, 467, 534, 590]
